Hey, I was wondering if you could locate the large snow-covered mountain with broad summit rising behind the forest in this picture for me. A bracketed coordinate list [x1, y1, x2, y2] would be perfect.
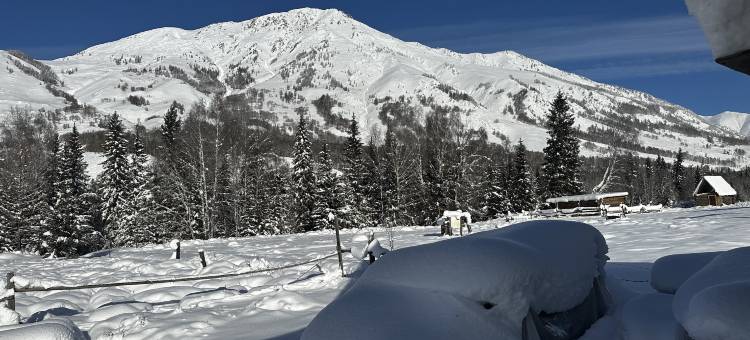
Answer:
[0, 8, 749, 166]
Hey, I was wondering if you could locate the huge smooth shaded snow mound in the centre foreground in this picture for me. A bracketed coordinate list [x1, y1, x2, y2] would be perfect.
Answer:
[303, 221, 607, 340]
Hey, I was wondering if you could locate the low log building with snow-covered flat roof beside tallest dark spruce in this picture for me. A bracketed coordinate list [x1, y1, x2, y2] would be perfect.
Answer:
[547, 192, 628, 215]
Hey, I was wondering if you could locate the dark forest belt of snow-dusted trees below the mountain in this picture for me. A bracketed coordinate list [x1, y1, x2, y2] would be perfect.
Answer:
[0, 94, 748, 257]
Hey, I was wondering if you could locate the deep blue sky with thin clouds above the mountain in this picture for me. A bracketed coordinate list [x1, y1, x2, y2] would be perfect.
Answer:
[0, 0, 750, 115]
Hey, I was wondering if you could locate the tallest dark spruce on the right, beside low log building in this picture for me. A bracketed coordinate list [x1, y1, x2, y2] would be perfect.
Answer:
[542, 93, 581, 198]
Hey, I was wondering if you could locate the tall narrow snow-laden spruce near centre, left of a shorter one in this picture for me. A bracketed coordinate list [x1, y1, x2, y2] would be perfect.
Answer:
[292, 110, 315, 231]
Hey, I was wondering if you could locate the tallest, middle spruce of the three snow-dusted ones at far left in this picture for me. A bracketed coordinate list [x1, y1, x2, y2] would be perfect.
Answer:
[99, 113, 133, 239]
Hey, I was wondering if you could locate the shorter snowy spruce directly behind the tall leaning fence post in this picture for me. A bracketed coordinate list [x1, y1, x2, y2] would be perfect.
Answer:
[313, 143, 339, 230]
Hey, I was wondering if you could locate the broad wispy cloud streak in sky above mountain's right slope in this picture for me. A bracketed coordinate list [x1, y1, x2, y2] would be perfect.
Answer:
[394, 16, 709, 62]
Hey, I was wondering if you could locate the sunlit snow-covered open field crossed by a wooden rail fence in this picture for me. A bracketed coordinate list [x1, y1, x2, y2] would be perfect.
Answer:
[0, 205, 750, 339]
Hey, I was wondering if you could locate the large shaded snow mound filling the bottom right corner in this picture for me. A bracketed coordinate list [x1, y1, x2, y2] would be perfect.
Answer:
[672, 247, 750, 340]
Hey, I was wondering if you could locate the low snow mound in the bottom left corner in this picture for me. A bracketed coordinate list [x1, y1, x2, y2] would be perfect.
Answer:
[0, 319, 87, 340]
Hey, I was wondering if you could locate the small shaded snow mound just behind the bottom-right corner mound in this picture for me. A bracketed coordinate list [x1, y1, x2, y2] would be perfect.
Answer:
[651, 252, 721, 294]
